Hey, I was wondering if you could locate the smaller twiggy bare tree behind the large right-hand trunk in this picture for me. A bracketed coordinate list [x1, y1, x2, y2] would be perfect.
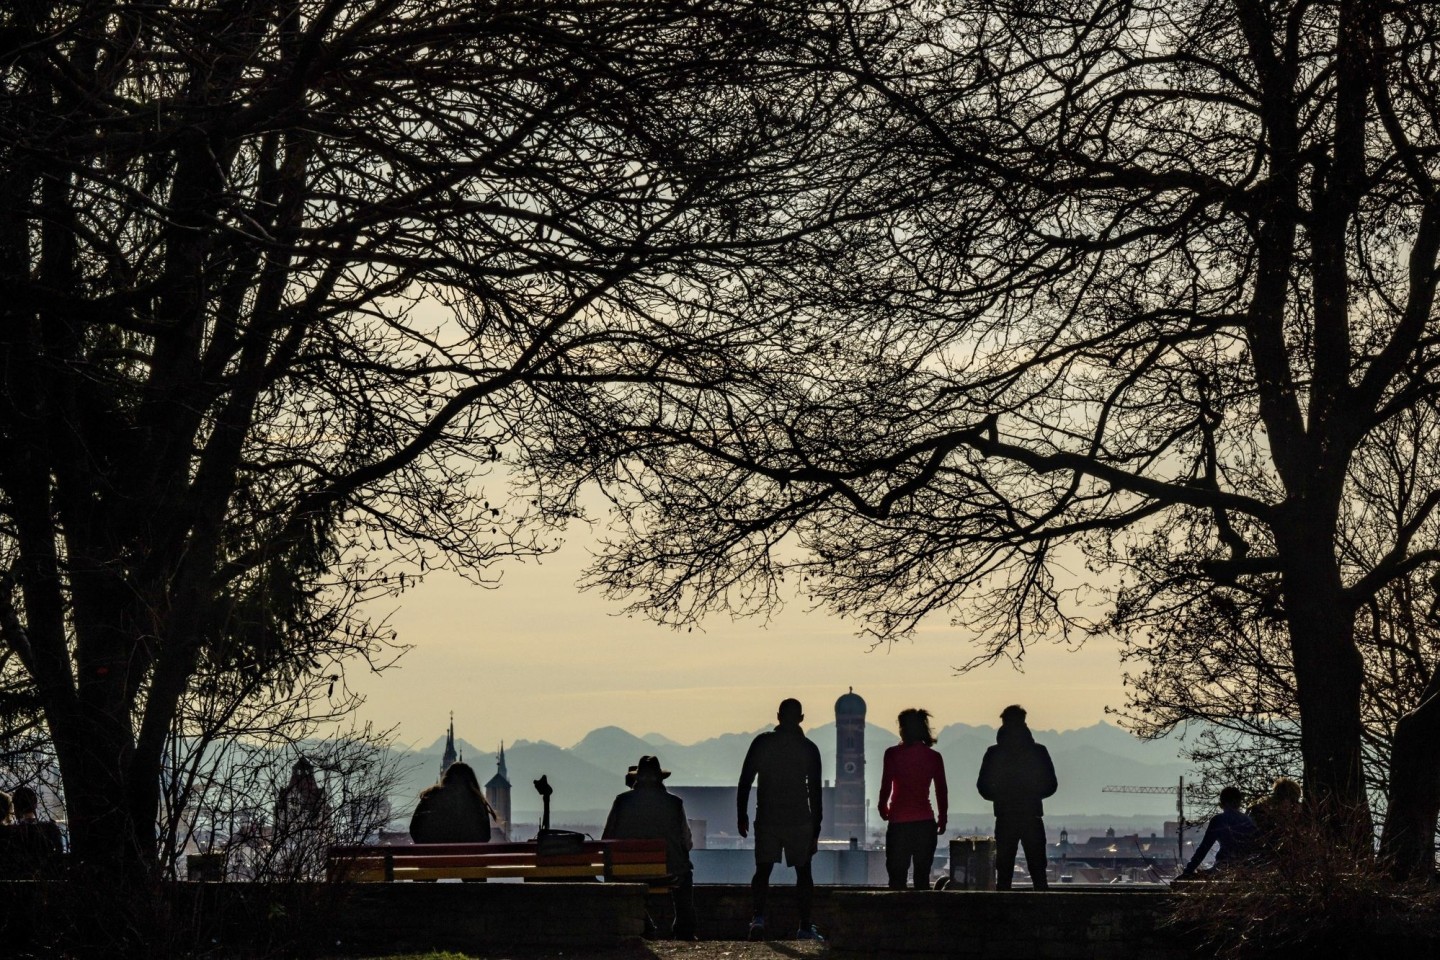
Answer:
[1104, 405, 1440, 864]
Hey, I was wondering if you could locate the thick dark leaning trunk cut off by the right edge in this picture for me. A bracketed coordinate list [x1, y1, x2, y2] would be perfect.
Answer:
[1380, 671, 1440, 879]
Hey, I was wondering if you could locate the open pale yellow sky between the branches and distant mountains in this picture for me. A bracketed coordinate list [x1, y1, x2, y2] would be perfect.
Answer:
[356, 529, 1122, 750]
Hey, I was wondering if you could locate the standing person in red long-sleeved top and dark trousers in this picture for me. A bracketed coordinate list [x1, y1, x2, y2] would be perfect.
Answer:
[880, 710, 949, 889]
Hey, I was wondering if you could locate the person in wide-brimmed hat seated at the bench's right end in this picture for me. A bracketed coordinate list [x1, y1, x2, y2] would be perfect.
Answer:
[602, 756, 696, 940]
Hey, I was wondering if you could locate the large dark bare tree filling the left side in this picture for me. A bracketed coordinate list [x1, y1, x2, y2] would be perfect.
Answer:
[0, 0, 806, 869]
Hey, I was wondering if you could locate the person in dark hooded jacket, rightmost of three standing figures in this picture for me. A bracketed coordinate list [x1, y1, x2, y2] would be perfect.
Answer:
[975, 705, 1058, 889]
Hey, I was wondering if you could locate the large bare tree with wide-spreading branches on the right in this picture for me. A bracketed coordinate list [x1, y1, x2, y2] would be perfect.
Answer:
[538, 0, 1440, 865]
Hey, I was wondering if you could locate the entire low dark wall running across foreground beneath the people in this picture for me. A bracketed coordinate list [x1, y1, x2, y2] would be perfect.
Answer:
[0, 882, 1192, 960]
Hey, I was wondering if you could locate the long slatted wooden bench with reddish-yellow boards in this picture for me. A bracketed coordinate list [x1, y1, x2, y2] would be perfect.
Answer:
[325, 841, 671, 887]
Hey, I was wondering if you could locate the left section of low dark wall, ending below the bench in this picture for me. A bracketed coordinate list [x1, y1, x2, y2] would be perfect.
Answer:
[0, 882, 645, 957]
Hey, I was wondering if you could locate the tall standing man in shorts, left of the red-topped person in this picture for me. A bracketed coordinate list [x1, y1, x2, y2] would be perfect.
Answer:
[736, 698, 824, 940]
